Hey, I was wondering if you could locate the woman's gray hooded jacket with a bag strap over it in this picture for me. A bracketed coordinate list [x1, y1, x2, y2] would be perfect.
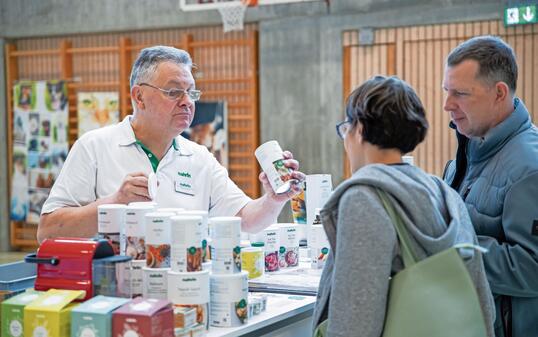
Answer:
[313, 164, 495, 337]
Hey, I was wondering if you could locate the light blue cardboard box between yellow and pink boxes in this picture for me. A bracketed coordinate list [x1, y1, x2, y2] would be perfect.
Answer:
[71, 295, 131, 337]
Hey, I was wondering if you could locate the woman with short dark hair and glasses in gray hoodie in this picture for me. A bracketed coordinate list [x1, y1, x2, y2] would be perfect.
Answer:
[314, 76, 495, 337]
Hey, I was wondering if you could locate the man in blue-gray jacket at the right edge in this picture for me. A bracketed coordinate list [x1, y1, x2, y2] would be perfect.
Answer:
[443, 36, 538, 337]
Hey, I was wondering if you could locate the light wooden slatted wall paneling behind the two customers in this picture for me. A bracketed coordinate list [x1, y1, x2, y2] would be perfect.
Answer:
[344, 20, 538, 175]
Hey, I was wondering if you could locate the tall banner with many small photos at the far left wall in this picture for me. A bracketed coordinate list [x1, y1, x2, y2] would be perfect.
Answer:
[10, 81, 69, 224]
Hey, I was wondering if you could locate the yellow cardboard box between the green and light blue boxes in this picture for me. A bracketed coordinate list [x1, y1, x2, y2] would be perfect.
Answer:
[24, 289, 86, 337]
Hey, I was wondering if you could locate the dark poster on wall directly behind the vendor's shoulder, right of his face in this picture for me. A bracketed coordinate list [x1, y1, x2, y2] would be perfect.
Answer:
[181, 102, 228, 168]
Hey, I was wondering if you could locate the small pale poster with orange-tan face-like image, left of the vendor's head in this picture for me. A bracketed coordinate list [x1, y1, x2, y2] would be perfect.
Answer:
[77, 92, 120, 137]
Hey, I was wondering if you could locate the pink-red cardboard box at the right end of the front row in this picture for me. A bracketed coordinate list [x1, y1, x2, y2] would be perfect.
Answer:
[112, 298, 174, 337]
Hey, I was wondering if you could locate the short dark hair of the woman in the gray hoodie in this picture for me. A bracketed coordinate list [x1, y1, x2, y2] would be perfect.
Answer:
[346, 76, 428, 153]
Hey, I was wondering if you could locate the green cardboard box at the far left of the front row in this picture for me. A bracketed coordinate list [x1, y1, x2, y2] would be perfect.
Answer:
[1, 290, 43, 337]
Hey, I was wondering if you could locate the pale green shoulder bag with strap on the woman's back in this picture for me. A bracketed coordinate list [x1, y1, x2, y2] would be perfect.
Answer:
[314, 189, 487, 337]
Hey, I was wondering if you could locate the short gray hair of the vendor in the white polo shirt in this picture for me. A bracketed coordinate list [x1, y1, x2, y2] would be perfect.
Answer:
[130, 46, 192, 88]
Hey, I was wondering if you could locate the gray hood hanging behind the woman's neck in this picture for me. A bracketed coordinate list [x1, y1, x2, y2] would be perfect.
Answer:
[321, 164, 466, 252]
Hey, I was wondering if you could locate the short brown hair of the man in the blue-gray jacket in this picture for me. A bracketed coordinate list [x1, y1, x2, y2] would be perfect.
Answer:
[446, 35, 517, 94]
